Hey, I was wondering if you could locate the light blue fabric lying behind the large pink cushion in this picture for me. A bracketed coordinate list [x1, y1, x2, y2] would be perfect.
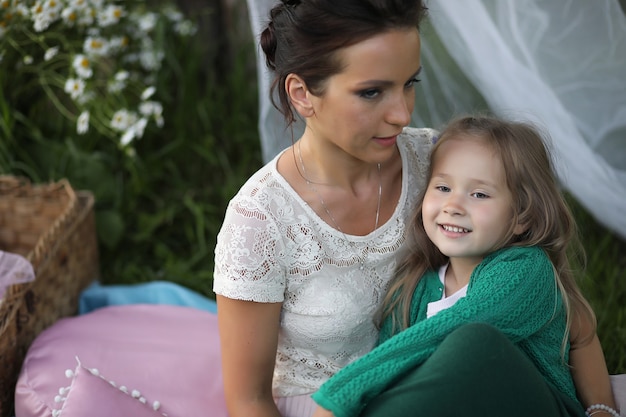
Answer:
[78, 281, 217, 314]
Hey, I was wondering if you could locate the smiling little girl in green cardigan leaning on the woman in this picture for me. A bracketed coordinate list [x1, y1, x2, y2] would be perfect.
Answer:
[313, 117, 618, 417]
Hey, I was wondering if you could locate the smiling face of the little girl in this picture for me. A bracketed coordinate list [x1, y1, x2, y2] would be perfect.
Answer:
[422, 135, 523, 264]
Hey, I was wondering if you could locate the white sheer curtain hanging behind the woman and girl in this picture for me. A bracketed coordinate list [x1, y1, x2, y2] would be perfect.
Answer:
[247, 0, 626, 238]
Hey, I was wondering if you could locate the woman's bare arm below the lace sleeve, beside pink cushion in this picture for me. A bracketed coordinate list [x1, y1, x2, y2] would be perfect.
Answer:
[217, 295, 282, 417]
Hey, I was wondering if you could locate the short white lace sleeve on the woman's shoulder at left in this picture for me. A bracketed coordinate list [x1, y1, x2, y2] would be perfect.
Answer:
[213, 195, 285, 303]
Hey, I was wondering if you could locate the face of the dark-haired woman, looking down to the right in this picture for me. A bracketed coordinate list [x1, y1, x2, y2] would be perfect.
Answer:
[307, 29, 421, 162]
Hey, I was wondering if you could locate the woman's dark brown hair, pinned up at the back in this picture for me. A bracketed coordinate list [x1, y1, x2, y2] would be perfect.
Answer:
[260, 0, 427, 125]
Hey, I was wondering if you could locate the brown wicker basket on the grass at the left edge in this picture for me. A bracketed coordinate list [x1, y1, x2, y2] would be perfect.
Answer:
[0, 176, 99, 417]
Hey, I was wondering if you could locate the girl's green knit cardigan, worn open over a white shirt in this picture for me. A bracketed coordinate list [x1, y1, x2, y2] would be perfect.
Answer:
[313, 247, 578, 417]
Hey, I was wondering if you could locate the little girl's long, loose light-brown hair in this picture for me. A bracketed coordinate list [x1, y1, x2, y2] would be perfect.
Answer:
[383, 116, 596, 347]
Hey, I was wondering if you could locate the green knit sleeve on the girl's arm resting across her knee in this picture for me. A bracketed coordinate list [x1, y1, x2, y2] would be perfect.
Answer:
[313, 248, 561, 417]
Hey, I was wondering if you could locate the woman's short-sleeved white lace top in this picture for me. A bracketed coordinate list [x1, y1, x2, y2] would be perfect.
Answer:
[213, 128, 435, 397]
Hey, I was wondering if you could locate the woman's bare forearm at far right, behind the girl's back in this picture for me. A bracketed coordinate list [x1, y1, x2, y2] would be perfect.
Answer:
[569, 313, 615, 417]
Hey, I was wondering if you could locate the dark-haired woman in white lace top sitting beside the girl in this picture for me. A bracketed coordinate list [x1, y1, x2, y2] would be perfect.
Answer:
[214, 0, 612, 417]
